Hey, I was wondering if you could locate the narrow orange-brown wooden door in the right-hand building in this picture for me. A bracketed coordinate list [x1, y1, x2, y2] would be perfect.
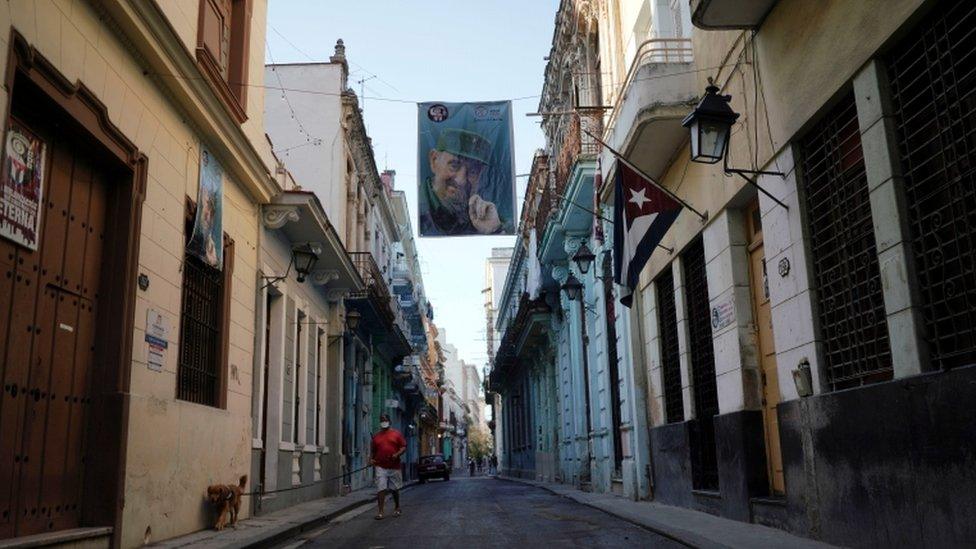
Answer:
[747, 202, 785, 495]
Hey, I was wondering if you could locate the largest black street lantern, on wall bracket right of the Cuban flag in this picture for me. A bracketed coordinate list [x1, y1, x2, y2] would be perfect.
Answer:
[681, 78, 739, 164]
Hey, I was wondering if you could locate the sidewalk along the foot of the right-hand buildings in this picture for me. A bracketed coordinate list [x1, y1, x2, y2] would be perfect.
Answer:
[496, 476, 833, 549]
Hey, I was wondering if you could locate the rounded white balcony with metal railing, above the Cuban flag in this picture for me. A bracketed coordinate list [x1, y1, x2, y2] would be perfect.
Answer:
[603, 38, 700, 183]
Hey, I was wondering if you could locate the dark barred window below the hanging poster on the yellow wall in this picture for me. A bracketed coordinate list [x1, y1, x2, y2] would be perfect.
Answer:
[176, 200, 234, 408]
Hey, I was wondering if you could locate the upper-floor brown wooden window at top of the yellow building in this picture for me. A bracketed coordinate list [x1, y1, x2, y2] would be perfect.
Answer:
[197, 0, 251, 122]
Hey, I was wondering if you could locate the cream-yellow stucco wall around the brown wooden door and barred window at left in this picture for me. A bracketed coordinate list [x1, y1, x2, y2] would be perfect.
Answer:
[0, 0, 278, 547]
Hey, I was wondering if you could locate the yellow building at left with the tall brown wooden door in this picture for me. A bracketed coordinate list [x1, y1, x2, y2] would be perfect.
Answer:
[0, 0, 280, 547]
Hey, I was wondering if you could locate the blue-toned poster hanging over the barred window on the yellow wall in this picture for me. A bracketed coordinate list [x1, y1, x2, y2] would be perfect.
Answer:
[186, 149, 224, 269]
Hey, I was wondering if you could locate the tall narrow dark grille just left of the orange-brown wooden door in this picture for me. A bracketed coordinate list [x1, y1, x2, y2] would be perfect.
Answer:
[681, 237, 718, 490]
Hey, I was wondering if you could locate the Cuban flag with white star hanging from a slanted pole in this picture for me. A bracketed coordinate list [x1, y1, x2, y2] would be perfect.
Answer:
[613, 160, 681, 307]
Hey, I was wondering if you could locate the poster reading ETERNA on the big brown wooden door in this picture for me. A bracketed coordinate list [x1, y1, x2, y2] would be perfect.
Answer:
[0, 119, 46, 250]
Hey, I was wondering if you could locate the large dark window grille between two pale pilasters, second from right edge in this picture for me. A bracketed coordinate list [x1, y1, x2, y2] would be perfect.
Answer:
[800, 93, 892, 390]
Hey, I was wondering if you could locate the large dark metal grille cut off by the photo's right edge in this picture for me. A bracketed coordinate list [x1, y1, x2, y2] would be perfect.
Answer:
[887, 1, 976, 368]
